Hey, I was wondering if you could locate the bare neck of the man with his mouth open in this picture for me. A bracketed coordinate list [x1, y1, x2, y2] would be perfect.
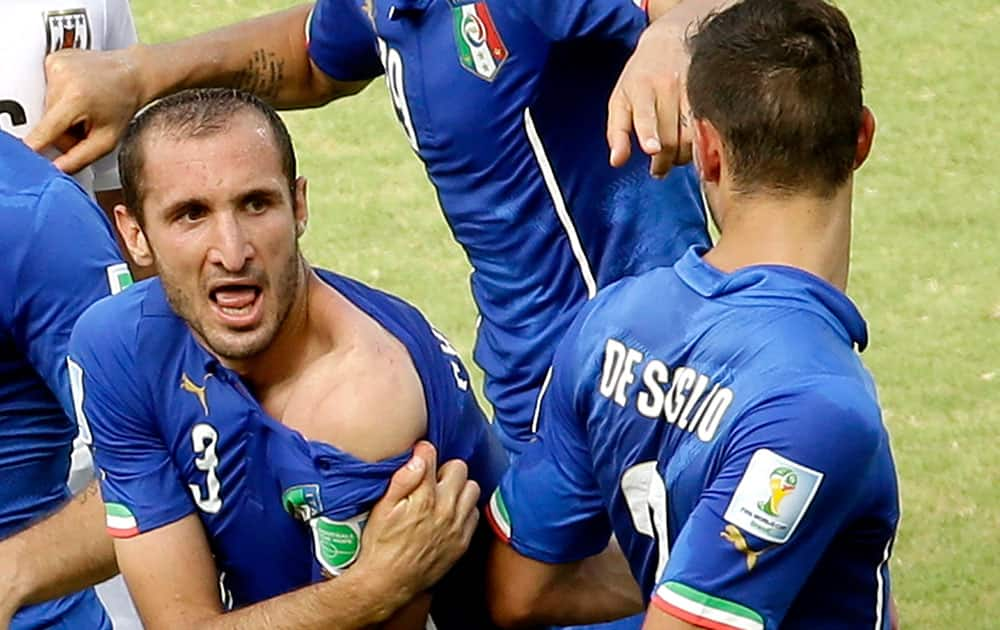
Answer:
[226, 266, 330, 397]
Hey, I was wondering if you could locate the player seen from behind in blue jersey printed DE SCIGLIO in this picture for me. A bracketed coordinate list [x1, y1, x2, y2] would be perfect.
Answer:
[490, 0, 899, 630]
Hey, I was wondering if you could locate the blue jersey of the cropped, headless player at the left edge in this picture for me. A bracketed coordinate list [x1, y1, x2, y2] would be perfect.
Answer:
[0, 132, 124, 630]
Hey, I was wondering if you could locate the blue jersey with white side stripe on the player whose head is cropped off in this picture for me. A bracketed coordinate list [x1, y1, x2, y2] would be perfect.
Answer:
[309, 0, 707, 451]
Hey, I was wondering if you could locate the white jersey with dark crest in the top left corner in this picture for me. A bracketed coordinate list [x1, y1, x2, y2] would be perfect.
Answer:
[0, 0, 136, 192]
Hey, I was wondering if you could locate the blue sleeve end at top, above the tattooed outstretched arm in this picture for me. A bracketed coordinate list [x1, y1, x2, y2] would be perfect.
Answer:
[306, 0, 383, 81]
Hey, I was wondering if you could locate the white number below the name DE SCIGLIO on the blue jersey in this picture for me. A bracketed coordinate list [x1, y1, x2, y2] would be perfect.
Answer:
[621, 460, 670, 580]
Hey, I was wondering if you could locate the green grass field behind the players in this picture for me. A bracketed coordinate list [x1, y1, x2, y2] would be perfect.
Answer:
[132, 0, 1000, 629]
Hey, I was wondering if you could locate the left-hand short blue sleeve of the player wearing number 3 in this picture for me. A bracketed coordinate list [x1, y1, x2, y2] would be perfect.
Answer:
[70, 304, 195, 538]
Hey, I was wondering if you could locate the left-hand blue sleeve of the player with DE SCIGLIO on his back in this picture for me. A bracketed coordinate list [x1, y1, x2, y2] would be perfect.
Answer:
[487, 332, 611, 563]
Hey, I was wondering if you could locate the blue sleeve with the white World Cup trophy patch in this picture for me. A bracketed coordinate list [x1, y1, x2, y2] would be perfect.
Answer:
[653, 383, 888, 629]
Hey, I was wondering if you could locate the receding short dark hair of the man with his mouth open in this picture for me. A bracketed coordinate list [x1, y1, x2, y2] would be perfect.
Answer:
[118, 88, 296, 223]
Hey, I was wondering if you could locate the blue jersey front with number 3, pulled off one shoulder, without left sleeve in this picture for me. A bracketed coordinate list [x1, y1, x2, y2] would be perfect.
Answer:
[139, 284, 502, 624]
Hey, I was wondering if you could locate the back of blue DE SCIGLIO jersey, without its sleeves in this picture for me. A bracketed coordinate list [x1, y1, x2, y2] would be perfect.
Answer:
[587, 262, 898, 628]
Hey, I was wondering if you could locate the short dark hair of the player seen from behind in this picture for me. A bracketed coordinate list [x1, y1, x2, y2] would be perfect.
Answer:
[687, 0, 862, 196]
